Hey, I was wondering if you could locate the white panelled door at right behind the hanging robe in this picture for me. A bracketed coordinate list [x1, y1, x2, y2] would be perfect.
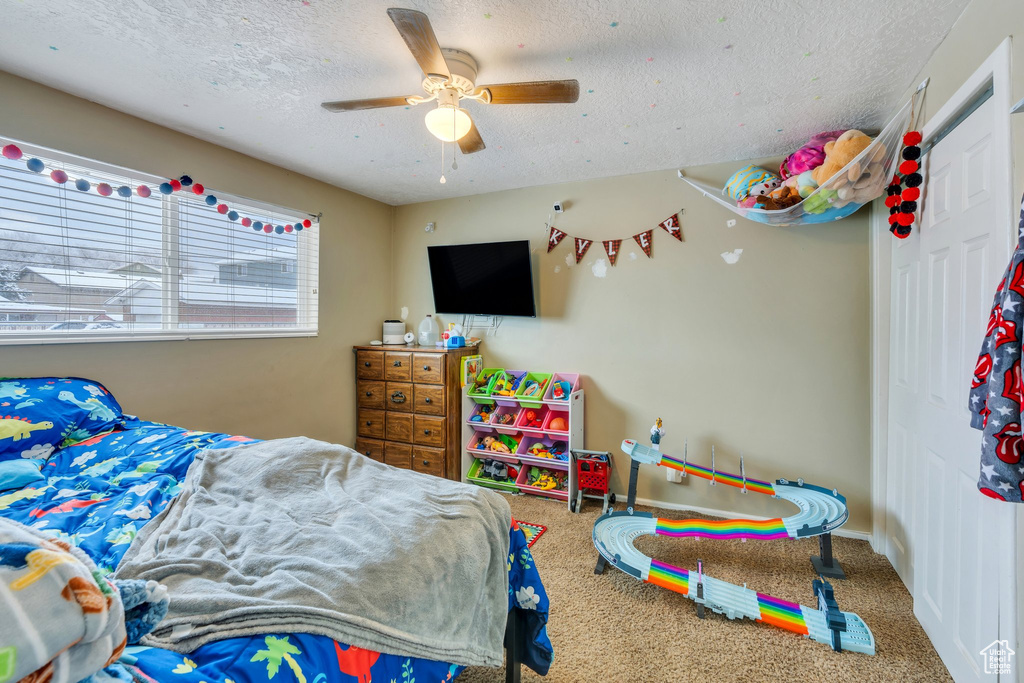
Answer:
[886, 92, 1015, 681]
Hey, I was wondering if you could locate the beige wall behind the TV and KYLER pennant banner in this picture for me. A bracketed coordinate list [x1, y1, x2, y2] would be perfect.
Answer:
[392, 163, 869, 530]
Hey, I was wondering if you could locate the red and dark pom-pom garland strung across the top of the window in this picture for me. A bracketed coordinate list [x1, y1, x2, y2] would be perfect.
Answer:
[0, 143, 313, 234]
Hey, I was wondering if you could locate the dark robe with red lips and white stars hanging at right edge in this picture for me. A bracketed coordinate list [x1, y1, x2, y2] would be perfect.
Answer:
[970, 191, 1024, 503]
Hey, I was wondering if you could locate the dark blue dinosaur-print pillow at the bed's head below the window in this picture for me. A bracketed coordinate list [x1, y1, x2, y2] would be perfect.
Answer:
[0, 377, 124, 461]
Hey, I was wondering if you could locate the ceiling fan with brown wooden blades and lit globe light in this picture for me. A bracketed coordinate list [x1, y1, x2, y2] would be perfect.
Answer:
[321, 8, 580, 155]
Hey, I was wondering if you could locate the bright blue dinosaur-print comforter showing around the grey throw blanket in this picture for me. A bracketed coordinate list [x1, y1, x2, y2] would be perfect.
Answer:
[0, 418, 553, 683]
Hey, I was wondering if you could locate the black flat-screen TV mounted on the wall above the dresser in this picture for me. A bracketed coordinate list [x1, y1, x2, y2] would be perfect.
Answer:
[427, 240, 537, 317]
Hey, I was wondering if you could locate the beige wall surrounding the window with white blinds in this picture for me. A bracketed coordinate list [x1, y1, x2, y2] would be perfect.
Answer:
[0, 72, 392, 443]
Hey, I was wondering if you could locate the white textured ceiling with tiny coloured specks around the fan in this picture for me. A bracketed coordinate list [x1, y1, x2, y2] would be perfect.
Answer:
[0, 0, 968, 204]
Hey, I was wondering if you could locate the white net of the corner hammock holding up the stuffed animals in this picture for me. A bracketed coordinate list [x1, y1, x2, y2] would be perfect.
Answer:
[679, 98, 914, 225]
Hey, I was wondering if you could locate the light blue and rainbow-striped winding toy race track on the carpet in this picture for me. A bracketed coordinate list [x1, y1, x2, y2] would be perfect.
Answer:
[593, 439, 874, 654]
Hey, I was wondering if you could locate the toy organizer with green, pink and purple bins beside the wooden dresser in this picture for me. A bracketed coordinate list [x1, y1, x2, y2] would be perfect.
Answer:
[462, 368, 584, 505]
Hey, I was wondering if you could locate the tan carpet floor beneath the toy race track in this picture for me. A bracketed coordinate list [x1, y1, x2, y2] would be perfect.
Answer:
[459, 496, 952, 683]
